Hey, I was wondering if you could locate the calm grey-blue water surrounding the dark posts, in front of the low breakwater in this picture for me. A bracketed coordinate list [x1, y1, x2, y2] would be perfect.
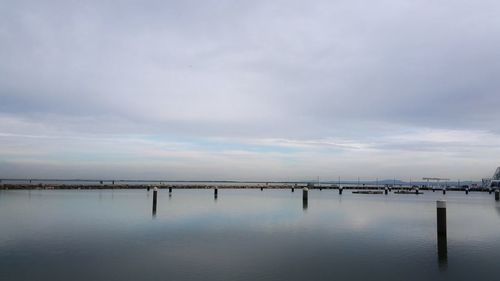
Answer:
[0, 190, 500, 281]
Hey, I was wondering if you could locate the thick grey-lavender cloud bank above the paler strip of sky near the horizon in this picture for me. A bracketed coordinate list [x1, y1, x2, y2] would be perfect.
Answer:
[0, 0, 500, 178]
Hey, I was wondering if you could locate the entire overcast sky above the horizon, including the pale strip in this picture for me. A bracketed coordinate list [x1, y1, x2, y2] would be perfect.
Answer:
[0, 0, 500, 181]
